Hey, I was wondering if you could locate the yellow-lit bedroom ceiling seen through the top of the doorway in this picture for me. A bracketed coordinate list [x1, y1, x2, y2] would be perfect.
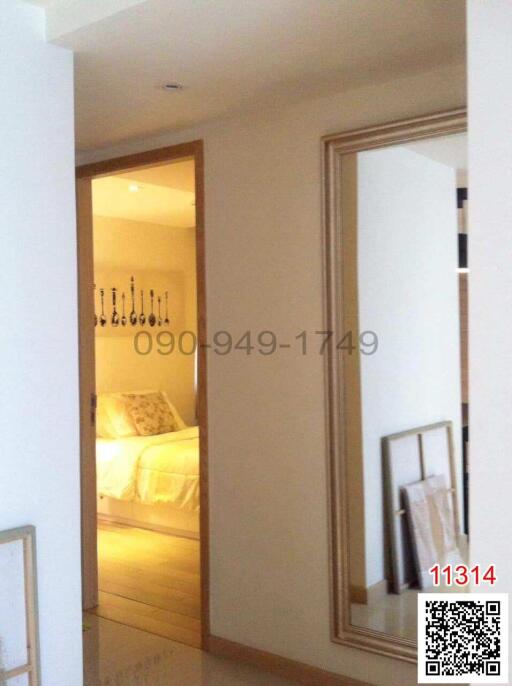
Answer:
[92, 160, 195, 228]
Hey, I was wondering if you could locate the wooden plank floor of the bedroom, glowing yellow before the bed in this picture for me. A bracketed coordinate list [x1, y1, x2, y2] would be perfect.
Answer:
[93, 522, 201, 648]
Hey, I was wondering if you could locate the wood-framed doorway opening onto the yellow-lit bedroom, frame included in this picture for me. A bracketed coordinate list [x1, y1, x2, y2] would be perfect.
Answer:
[77, 141, 209, 647]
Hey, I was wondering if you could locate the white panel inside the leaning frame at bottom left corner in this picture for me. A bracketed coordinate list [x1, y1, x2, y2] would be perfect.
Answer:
[0, 540, 28, 686]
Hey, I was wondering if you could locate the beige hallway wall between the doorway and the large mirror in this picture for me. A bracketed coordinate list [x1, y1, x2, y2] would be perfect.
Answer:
[80, 61, 465, 686]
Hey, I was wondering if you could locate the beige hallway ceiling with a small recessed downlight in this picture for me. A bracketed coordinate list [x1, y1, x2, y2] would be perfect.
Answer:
[36, 0, 465, 150]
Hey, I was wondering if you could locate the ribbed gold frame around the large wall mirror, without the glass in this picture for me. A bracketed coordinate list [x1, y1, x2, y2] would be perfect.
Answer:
[323, 109, 467, 662]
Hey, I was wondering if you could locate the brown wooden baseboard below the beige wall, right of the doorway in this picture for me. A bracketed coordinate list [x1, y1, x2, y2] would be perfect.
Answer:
[205, 636, 371, 686]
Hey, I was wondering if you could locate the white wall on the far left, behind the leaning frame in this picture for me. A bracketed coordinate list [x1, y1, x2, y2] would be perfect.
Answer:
[0, 0, 82, 686]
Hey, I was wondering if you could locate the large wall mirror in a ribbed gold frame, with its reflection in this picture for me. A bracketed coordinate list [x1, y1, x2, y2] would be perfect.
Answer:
[323, 110, 469, 662]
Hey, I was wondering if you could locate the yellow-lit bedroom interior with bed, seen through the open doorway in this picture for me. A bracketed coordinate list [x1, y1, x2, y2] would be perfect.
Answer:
[88, 158, 201, 647]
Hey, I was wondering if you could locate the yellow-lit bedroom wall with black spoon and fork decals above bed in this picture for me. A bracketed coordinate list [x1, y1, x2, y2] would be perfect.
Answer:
[94, 216, 197, 425]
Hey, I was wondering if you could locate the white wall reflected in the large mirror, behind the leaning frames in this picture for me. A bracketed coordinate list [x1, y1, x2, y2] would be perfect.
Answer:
[357, 147, 462, 586]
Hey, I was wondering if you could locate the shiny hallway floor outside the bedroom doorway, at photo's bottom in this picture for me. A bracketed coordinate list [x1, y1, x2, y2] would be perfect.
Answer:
[84, 614, 292, 686]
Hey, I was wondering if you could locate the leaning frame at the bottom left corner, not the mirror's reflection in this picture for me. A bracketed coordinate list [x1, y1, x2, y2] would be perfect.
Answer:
[0, 526, 41, 686]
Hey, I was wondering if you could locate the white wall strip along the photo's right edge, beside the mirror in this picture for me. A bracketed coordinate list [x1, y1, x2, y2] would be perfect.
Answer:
[468, 0, 512, 636]
